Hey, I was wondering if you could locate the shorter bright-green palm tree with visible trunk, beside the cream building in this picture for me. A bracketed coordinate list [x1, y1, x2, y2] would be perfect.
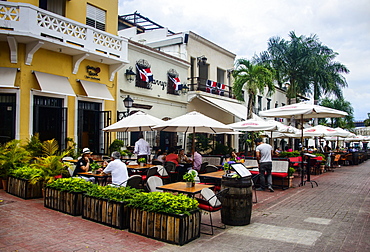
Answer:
[233, 59, 275, 119]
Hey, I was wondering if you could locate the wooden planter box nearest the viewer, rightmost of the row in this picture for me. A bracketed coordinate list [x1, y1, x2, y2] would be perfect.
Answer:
[129, 208, 201, 245]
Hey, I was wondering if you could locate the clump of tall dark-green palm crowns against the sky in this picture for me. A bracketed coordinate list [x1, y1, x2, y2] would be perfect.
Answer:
[254, 31, 349, 103]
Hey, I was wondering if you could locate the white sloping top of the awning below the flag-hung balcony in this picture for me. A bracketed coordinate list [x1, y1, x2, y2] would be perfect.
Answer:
[197, 95, 247, 120]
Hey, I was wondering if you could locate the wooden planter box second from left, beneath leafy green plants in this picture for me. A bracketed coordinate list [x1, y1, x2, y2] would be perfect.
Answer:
[44, 188, 83, 216]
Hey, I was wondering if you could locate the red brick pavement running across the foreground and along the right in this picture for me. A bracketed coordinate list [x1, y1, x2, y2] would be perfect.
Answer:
[0, 160, 370, 252]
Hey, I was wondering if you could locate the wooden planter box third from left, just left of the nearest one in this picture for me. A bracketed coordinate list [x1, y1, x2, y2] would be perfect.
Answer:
[82, 195, 130, 229]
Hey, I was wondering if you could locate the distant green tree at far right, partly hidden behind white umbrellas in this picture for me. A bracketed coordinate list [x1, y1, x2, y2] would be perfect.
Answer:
[320, 98, 355, 129]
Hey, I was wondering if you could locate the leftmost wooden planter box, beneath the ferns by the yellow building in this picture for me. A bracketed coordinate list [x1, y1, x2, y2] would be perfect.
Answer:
[6, 177, 42, 199]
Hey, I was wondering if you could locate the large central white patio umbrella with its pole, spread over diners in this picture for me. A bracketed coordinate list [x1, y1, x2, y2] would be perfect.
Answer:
[153, 111, 233, 157]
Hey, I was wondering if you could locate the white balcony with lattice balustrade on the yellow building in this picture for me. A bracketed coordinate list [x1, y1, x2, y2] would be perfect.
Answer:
[0, 2, 128, 79]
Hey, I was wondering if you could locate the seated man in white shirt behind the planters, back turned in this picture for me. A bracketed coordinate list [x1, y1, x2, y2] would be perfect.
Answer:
[98, 151, 128, 186]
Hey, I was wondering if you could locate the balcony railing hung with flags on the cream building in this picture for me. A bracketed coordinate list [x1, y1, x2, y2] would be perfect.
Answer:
[188, 77, 235, 99]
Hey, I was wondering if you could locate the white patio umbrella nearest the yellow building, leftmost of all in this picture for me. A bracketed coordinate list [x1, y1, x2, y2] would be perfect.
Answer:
[103, 111, 163, 132]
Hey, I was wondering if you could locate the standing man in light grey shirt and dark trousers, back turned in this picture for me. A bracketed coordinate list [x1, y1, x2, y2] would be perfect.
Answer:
[255, 138, 274, 192]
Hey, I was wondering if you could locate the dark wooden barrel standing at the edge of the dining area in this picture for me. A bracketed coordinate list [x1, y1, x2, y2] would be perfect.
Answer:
[221, 176, 252, 226]
